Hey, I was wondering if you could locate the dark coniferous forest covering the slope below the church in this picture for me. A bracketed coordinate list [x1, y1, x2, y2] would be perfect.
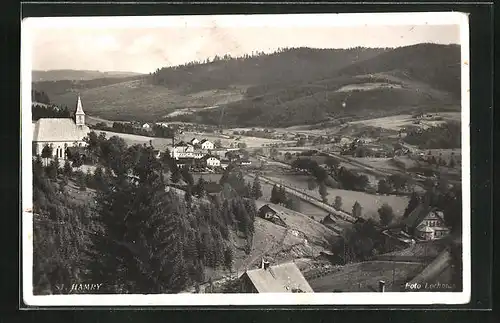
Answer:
[33, 132, 256, 295]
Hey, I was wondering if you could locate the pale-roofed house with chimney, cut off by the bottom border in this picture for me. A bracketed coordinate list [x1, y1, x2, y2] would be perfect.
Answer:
[239, 260, 314, 293]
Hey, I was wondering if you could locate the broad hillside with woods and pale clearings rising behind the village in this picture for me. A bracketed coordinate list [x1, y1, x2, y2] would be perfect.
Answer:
[34, 44, 460, 127]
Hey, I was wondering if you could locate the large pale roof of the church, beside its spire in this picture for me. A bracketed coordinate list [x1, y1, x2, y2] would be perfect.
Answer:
[33, 118, 90, 141]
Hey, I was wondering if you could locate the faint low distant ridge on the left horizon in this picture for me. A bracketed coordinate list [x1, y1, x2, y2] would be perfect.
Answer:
[32, 69, 142, 82]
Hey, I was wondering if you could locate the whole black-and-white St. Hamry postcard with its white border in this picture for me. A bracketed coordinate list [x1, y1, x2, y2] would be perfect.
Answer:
[21, 12, 471, 306]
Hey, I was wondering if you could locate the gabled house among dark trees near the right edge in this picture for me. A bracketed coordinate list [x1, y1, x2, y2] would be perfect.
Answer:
[403, 204, 450, 240]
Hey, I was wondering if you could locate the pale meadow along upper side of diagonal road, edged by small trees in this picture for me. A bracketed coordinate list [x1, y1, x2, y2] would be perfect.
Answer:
[266, 174, 408, 220]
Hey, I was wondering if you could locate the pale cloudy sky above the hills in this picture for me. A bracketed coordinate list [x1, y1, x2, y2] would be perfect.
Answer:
[29, 15, 460, 73]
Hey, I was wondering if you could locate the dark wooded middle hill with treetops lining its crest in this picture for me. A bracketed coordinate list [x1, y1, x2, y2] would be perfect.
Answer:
[151, 47, 388, 91]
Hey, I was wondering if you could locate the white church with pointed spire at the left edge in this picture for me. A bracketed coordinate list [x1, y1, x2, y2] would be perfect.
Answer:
[32, 96, 90, 159]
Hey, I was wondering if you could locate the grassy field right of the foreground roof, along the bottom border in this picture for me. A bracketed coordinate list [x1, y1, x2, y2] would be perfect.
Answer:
[309, 261, 425, 293]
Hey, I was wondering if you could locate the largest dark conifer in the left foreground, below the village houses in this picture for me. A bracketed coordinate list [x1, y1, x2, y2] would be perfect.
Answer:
[88, 148, 189, 293]
